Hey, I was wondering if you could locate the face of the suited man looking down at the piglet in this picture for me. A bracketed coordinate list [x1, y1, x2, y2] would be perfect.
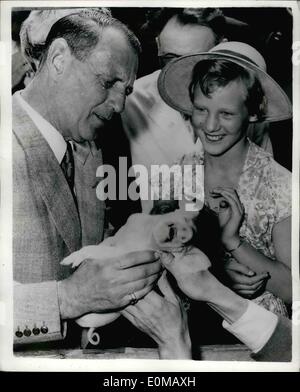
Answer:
[58, 28, 138, 142]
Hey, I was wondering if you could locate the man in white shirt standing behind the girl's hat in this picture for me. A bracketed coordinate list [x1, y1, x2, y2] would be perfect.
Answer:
[122, 8, 272, 212]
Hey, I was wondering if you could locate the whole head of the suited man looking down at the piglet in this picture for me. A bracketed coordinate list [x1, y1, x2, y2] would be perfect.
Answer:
[24, 10, 140, 142]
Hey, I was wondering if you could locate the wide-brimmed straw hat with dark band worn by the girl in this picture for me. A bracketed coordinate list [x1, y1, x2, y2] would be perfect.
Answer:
[158, 41, 292, 121]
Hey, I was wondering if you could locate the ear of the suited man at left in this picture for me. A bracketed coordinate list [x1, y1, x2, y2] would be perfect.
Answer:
[48, 38, 71, 77]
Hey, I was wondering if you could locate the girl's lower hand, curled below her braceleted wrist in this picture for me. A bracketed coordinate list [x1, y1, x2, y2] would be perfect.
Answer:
[225, 259, 270, 299]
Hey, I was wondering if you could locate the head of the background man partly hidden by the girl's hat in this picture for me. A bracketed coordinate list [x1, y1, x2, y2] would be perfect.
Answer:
[144, 8, 226, 67]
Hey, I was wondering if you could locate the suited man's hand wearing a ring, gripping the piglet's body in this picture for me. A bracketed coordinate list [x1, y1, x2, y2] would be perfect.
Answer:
[58, 251, 161, 319]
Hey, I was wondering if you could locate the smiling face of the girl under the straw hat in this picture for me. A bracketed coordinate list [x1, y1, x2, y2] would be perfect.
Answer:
[192, 80, 252, 156]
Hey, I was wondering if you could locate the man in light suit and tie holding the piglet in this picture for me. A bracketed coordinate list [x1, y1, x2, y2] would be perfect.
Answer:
[13, 10, 160, 344]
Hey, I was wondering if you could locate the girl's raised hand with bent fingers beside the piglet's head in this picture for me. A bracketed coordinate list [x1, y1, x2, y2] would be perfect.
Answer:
[210, 187, 244, 250]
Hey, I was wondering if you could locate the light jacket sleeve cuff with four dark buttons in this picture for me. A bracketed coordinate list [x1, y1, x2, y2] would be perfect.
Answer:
[14, 281, 66, 344]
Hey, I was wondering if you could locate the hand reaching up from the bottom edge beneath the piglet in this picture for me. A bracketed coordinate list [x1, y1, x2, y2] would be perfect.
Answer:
[121, 273, 191, 359]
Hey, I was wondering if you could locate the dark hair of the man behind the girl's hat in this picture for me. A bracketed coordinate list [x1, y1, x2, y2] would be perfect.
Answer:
[143, 8, 226, 43]
